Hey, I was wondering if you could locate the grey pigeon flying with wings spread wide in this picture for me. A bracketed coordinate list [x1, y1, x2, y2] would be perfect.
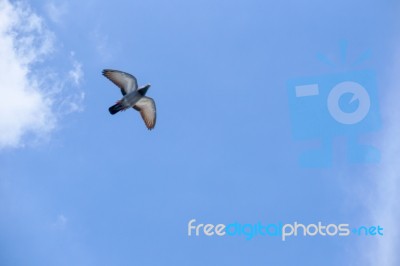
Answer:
[103, 69, 156, 130]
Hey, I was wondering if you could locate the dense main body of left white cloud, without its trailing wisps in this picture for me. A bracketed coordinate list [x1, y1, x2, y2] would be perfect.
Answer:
[0, 0, 56, 148]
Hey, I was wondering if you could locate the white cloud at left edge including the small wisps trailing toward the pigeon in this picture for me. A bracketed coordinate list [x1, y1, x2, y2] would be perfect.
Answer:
[0, 0, 83, 149]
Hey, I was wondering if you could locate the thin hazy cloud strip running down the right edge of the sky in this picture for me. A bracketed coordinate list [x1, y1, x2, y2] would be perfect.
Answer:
[363, 43, 400, 266]
